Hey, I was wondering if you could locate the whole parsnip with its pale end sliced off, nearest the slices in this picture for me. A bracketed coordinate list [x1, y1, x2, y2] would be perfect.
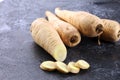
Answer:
[30, 18, 67, 61]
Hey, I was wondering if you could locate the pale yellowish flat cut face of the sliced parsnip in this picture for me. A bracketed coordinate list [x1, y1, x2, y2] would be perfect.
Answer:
[53, 45, 67, 61]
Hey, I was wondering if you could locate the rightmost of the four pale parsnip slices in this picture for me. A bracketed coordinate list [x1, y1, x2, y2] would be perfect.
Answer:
[75, 60, 90, 69]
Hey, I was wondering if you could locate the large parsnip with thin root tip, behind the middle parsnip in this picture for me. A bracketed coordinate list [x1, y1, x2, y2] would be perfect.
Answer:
[55, 8, 103, 37]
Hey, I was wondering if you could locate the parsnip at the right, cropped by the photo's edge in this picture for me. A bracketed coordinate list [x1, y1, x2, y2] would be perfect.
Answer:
[101, 19, 120, 42]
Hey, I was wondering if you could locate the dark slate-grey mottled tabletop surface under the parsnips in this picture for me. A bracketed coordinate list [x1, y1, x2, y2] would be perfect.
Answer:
[0, 0, 120, 80]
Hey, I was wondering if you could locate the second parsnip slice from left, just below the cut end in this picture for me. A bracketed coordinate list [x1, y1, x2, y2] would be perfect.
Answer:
[55, 61, 69, 73]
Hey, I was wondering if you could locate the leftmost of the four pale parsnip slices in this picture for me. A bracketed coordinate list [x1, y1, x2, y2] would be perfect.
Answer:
[40, 61, 56, 71]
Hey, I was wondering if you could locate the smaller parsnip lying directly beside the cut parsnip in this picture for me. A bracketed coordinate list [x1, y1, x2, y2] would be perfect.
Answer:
[45, 11, 81, 47]
